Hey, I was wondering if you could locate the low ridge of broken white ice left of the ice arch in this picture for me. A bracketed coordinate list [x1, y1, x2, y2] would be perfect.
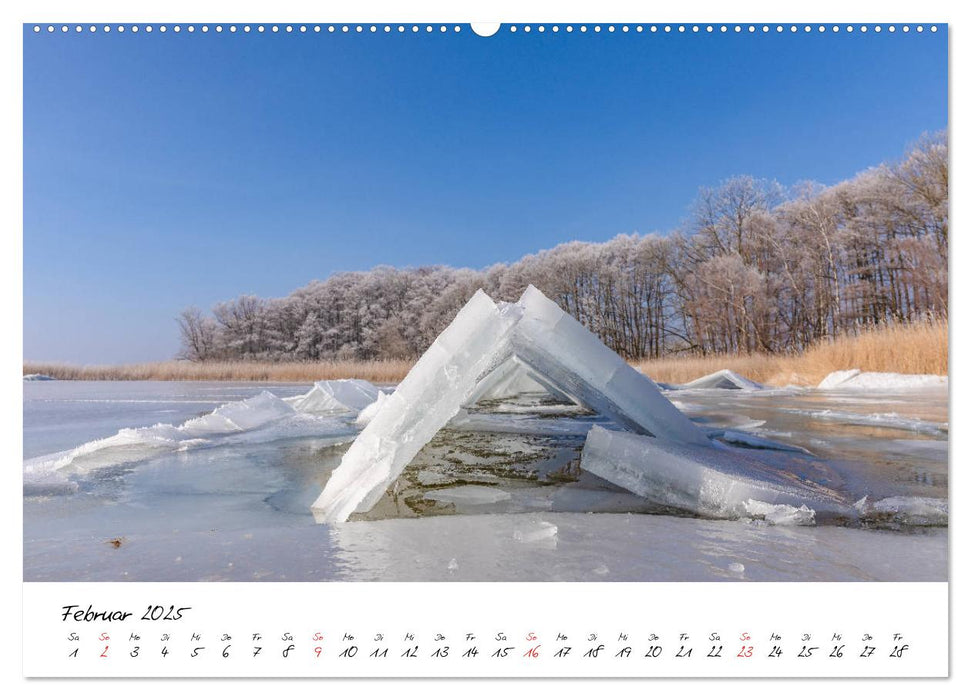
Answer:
[24, 391, 353, 492]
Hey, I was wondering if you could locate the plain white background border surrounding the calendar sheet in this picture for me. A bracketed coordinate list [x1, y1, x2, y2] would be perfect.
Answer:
[0, 0, 968, 698]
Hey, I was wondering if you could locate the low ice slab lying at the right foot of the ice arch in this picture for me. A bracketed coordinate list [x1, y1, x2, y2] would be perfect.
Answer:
[580, 426, 855, 523]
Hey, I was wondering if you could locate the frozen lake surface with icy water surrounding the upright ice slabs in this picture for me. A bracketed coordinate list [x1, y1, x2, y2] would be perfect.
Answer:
[24, 381, 948, 581]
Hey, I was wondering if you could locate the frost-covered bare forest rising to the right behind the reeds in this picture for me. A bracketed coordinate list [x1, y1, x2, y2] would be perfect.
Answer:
[178, 133, 948, 361]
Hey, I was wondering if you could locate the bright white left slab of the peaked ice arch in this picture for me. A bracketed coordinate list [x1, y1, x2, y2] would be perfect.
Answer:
[312, 290, 521, 522]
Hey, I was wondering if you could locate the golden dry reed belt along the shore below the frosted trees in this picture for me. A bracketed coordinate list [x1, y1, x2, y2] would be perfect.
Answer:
[24, 320, 948, 386]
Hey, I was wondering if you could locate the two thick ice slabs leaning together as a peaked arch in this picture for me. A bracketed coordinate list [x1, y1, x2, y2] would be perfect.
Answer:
[312, 286, 711, 522]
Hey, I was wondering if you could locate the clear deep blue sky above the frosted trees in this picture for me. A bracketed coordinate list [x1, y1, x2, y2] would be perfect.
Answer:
[24, 27, 947, 363]
